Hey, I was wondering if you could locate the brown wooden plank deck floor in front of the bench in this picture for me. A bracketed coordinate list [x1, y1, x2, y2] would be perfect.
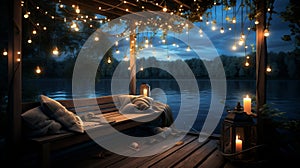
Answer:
[22, 134, 296, 168]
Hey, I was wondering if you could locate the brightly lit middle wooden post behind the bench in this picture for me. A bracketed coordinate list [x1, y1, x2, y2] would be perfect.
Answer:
[129, 29, 136, 95]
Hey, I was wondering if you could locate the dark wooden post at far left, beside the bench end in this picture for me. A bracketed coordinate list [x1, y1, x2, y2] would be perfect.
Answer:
[6, 0, 22, 165]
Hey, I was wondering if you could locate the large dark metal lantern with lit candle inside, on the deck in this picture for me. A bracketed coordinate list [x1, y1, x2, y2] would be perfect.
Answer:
[221, 102, 256, 160]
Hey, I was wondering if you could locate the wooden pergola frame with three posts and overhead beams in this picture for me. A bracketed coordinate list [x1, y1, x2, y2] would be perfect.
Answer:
[6, 0, 267, 164]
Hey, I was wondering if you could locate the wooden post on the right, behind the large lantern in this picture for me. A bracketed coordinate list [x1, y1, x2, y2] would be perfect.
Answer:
[256, 0, 267, 144]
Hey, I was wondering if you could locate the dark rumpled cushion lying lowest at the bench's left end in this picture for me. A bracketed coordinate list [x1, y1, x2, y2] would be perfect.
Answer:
[21, 106, 62, 137]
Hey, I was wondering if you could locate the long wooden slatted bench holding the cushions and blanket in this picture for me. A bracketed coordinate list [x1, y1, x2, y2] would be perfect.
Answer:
[22, 96, 165, 167]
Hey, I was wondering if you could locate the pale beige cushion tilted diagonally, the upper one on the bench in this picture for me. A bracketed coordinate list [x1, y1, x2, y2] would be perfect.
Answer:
[39, 95, 84, 133]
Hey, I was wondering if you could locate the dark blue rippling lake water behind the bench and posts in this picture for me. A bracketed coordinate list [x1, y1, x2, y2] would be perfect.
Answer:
[23, 79, 300, 133]
